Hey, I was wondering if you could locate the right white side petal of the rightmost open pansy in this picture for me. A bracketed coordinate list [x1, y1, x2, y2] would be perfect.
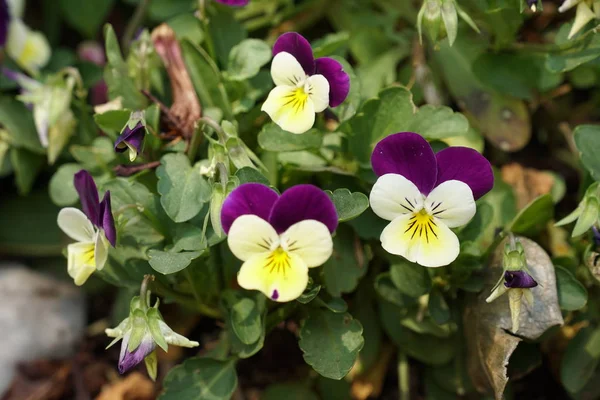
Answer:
[425, 180, 477, 228]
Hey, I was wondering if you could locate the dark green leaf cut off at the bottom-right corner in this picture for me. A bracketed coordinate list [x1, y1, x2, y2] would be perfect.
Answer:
[560, 326, 600, 393]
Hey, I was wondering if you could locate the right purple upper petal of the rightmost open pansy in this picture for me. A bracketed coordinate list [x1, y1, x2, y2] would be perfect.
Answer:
[436, 147, 494, 200]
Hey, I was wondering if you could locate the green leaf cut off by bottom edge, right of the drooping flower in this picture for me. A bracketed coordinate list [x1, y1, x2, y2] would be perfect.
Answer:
[159, 357, 237, 400]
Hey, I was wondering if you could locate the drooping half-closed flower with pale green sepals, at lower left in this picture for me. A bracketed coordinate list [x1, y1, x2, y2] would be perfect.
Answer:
[105, 297, 199, 380]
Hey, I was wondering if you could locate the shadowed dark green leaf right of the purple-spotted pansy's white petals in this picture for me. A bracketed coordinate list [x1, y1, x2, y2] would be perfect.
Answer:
[323, 225, 367, 297]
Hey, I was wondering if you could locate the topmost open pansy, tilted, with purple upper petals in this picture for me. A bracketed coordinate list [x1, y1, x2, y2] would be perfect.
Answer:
[262, 32, 350, 133]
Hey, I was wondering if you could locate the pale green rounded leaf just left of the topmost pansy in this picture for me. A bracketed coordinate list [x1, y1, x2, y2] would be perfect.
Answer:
[227, 39, 271, 81]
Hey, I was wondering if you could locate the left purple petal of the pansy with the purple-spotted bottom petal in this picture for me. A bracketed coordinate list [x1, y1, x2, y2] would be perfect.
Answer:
[221, 183, 279, 233]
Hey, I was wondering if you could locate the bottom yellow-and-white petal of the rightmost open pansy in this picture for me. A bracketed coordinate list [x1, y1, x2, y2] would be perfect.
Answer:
[381, 214, 460, 267]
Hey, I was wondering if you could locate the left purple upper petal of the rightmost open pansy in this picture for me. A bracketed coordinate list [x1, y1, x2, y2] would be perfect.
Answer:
[371, 132, 437, 195]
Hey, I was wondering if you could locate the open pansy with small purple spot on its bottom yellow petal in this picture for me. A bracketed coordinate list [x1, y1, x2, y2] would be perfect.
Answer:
[221, 183, 338, 302]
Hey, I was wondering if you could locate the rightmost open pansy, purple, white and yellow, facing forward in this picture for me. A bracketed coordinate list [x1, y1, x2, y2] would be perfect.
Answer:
[370, 132, 494, 267]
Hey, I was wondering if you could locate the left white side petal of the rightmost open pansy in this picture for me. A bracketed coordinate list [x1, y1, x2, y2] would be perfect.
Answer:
[369, 174, 424, 221]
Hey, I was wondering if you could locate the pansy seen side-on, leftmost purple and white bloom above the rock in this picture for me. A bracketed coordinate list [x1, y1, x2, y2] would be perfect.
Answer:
[57, 170, 117, 286]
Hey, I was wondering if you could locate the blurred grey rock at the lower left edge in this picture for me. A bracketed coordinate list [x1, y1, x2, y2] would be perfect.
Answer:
[0, 263, 86, 397]
